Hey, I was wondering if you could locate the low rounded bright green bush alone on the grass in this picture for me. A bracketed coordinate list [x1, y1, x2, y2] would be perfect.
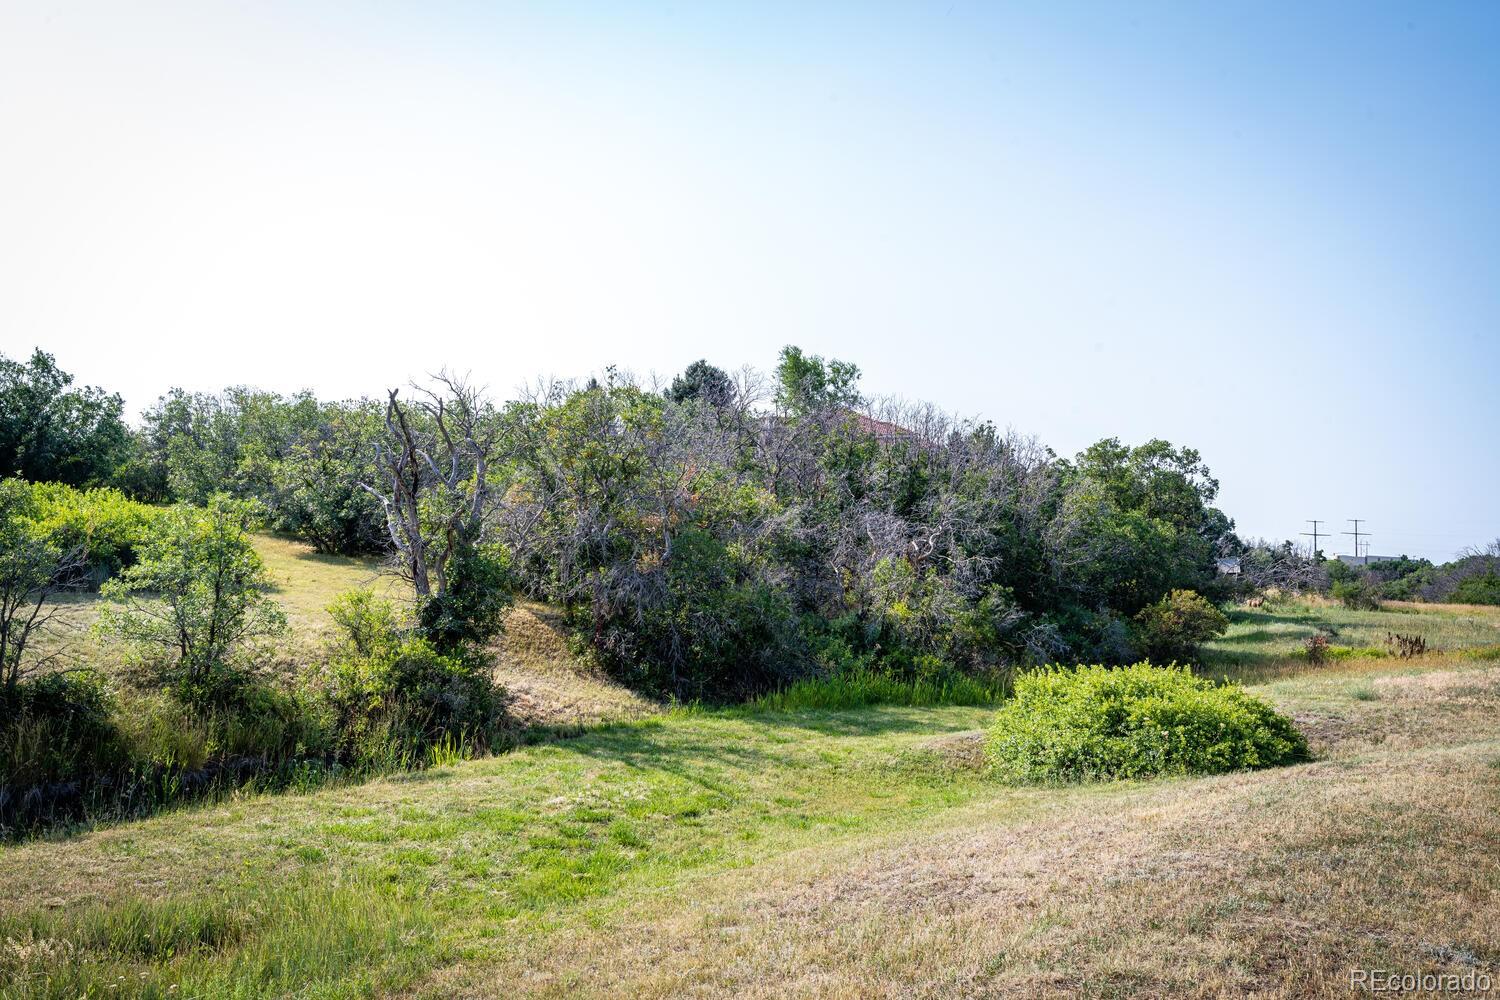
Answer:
[987, 663, 1308, 781]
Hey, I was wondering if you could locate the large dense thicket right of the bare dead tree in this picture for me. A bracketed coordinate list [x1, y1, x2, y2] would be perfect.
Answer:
[357, 348, 1233, 699]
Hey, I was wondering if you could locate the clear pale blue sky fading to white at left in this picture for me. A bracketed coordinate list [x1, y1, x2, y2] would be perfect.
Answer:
[0, 1, 1500, 559]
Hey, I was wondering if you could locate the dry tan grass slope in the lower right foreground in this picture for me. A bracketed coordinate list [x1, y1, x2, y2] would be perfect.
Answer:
[428, 659, 1500, 997]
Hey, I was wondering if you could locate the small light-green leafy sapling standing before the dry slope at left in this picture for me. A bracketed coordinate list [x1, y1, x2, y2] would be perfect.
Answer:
[98, 496, 287, 702]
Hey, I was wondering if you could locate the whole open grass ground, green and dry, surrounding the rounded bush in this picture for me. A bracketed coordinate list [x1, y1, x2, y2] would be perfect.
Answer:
[0, 547, 1500, 997]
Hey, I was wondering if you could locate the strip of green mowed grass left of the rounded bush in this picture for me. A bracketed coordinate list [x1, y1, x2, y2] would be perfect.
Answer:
[0, 708, 1008, 996]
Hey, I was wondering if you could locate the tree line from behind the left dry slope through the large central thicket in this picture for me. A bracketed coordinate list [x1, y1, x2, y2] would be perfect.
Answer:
[8, 348, 1236, 699]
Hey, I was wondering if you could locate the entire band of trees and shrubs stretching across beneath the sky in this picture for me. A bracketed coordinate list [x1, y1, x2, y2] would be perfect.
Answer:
[0, 348, 1500, 832]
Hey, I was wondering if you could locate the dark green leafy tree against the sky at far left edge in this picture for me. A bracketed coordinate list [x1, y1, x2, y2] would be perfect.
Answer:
[0, 349, 131, 486]
